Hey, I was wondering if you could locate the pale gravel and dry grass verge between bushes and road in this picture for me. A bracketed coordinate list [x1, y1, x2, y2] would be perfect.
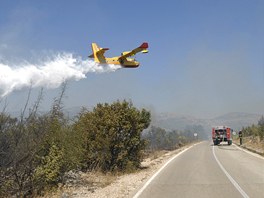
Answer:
[54, 144, 197, 198]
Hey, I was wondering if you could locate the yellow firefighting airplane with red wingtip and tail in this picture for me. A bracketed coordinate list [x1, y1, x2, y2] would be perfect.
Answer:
[89, 43, 148, 68]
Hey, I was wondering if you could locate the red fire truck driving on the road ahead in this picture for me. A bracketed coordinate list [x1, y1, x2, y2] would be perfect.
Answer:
[212, 126, 233, 145]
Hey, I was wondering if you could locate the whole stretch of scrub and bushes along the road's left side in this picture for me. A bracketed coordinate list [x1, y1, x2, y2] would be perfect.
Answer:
[0, 84, 197, 197]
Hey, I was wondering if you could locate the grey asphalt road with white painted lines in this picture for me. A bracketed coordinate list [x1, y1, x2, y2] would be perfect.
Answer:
[134, 142, 264, 198]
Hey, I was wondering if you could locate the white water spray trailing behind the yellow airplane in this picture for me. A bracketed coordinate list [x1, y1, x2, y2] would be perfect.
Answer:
[0, 53, 121, 98]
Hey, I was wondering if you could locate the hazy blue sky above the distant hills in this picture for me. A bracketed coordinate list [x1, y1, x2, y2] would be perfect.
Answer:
[0, 0, 264, 118]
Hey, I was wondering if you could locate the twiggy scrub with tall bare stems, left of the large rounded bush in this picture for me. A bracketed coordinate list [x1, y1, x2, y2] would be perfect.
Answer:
[0, 86, 82, 197]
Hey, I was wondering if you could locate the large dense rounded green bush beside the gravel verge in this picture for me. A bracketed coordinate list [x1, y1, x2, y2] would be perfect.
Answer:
[75, 100, 150, 171]
